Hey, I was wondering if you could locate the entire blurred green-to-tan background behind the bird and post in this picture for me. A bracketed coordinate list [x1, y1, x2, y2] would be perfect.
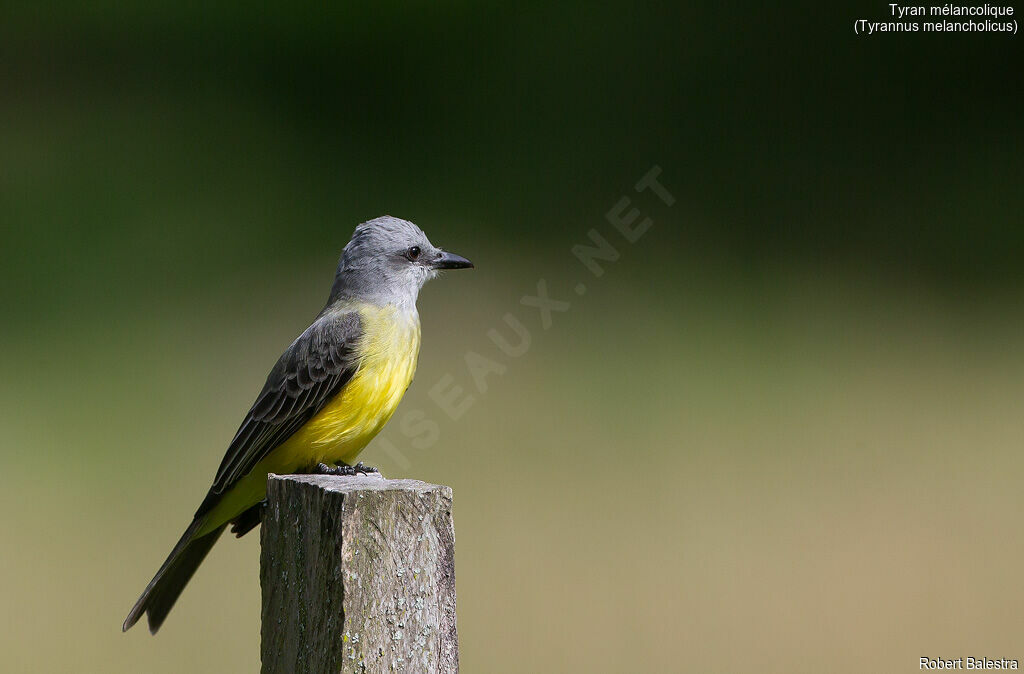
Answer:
[0, 1, 1024, 673]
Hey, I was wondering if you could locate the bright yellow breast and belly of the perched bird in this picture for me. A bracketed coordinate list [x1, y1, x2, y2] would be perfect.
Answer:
[201, 305, 420, 534]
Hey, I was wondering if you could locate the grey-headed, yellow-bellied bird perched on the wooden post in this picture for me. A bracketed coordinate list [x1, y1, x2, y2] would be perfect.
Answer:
[122, 215, 473, 634]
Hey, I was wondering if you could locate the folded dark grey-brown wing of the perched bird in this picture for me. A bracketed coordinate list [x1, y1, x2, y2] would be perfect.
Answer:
[200, 311, 362, 501]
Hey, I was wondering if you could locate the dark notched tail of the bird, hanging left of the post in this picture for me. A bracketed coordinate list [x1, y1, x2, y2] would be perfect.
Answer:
[121, 518, 226, 634]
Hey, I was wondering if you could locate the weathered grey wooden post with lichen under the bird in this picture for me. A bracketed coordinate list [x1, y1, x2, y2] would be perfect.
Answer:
[260, 475, 459, 674]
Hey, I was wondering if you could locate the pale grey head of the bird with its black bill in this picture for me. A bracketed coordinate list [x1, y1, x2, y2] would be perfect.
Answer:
[328, 215, 473, 308]
